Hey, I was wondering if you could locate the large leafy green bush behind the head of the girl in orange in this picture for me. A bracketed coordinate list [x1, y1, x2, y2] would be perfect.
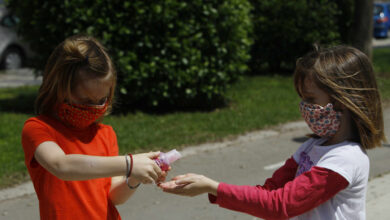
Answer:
[9, 0, 252, 109]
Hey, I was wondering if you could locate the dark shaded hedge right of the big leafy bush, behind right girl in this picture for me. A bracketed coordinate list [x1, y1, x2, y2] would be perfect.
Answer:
[250, 0, 345, 74]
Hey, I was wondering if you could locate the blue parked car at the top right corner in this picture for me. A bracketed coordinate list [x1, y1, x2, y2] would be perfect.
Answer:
[374, 3, 390, 38]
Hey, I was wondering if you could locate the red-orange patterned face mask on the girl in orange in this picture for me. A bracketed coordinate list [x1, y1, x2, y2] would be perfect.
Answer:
[57, 101, 108, 129]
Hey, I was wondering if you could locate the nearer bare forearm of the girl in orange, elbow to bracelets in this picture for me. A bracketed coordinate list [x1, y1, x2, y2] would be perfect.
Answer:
[50, 154, 126, 180]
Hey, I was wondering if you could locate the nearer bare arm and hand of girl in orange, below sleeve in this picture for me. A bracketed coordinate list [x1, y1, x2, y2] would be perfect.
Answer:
[34, 141, 162, 183]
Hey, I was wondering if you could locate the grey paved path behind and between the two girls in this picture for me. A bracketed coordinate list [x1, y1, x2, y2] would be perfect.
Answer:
[0, 108, 390, 220]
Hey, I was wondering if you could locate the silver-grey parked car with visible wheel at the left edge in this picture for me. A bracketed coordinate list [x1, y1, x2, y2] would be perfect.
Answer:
[0, 5, 32, 69]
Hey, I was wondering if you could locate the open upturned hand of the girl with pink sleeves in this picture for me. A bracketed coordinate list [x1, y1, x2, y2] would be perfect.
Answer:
[160, 173, 219, 196]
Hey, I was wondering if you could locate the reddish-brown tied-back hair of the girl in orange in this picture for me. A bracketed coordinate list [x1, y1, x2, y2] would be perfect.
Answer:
[35, 35, 116, 115]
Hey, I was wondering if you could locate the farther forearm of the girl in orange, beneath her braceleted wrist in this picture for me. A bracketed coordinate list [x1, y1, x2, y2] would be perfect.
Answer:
[109, 176, 140, 205]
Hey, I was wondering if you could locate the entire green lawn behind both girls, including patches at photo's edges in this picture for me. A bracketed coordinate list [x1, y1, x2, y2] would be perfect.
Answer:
[0, 48, 390, 188]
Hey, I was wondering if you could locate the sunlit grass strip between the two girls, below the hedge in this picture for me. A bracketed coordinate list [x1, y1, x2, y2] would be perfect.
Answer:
[109, 76, 299, 152]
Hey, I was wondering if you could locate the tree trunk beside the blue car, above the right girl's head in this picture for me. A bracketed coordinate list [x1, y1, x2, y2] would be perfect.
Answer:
[349, 0, 374, 59]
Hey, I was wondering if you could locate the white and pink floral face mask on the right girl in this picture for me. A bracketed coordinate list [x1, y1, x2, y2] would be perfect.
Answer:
[300, 101, 342, 137]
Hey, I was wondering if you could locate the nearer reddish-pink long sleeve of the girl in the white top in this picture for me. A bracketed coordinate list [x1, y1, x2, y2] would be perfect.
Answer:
[209, 166, 348, 219]
